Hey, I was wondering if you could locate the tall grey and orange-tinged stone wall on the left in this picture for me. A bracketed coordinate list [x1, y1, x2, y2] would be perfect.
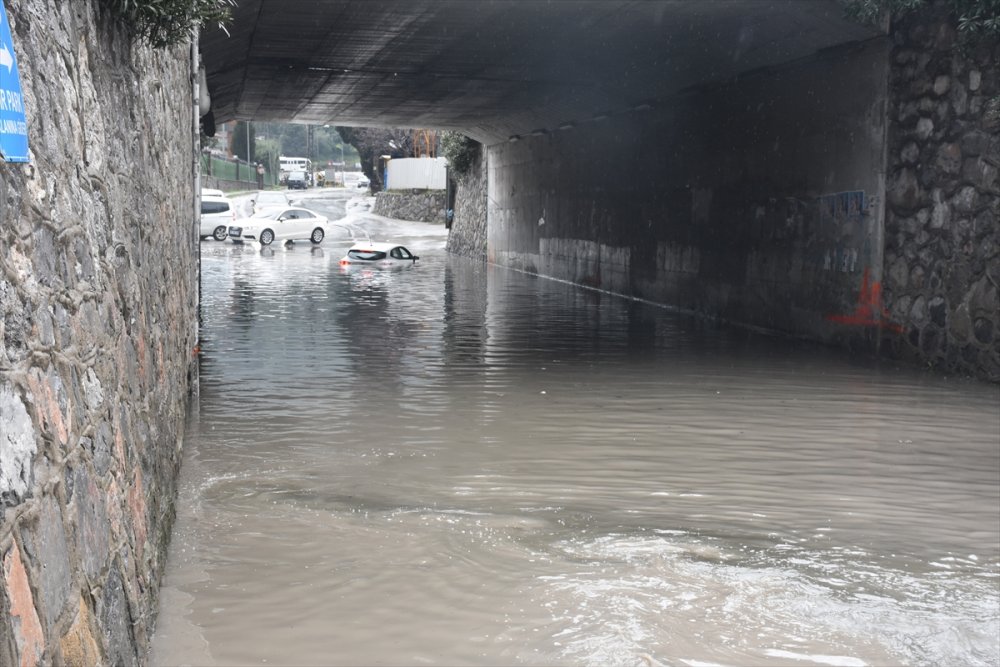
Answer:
[0, 0, 197, 666]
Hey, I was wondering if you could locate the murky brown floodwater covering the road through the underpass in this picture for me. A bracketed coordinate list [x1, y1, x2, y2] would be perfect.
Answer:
[151, 194, 1000, 667]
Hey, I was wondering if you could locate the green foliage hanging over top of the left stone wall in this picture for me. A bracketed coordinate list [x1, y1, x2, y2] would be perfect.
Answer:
[103, 0, 236, 48]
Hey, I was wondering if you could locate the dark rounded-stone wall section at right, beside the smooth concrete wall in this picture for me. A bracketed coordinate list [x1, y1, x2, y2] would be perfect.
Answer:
[882, 7, 1000, 381]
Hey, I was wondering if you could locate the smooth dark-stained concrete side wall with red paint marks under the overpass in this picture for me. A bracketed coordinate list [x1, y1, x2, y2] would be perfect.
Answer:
[488, 40, 889, 349]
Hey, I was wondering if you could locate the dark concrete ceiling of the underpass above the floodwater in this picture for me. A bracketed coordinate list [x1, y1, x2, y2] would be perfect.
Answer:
[201, 0, 877, 143]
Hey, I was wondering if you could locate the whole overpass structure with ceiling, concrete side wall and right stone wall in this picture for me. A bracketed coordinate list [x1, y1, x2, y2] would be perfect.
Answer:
[200, 0, 1000, 376]
